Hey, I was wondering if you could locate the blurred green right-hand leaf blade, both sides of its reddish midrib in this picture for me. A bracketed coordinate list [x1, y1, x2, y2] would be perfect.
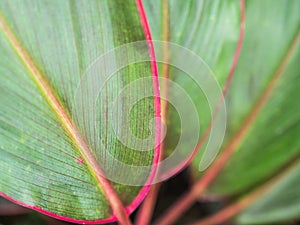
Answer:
[210, 1, 300, 194]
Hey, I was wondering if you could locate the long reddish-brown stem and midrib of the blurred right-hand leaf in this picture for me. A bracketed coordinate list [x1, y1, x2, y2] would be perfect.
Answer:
[155, 16, 300, 225]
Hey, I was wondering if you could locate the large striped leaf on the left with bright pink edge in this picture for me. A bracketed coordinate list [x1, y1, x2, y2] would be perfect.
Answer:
[0, 0, 157, 223]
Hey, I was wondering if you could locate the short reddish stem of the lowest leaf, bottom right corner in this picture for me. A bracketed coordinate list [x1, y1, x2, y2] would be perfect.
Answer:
[190, 157, 300, 225]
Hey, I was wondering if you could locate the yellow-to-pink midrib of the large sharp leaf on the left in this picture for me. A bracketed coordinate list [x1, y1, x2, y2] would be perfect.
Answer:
[0, 13, 125, 221]
